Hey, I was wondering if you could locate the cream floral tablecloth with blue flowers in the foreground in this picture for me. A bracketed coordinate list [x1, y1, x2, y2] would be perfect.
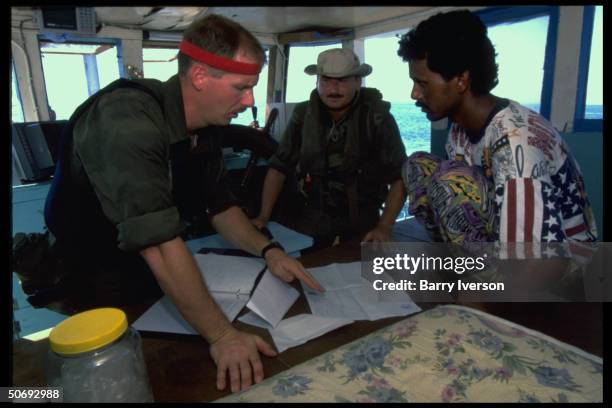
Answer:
[218, 305, 603, 402]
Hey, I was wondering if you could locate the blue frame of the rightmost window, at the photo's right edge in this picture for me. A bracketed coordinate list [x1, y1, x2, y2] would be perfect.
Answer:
[573, 5, 603, 132]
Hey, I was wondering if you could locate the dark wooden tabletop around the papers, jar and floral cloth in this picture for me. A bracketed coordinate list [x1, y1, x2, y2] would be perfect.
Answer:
[12, 239, 603, 402]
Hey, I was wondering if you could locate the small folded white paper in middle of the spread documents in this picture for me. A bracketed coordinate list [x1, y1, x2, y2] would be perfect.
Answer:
[247, 270, 300, 327]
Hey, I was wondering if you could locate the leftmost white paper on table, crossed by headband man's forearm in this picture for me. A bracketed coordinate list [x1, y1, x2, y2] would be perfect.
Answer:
[133, 254, 265, 334]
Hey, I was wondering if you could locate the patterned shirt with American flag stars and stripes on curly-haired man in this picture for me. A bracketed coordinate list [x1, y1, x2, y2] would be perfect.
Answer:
[446, 101, 597, 242]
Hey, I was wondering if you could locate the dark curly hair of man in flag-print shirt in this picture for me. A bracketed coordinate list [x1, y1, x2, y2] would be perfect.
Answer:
[397, 10, 499, 95]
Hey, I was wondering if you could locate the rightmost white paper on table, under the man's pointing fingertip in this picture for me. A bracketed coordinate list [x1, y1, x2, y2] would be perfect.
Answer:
[302, 262, 421, 320]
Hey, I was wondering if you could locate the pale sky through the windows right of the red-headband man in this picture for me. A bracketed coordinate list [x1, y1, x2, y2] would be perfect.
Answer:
[280, 7, 603, 104]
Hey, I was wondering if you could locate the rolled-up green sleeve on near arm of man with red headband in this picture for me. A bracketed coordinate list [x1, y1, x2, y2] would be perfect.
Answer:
[75, 90, 184, 251]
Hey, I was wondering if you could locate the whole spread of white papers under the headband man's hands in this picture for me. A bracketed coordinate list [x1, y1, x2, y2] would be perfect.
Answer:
[134, 254, 421, 352]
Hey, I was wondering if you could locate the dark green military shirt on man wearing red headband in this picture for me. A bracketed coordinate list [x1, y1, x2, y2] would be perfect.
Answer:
[71, 75, 233, 251]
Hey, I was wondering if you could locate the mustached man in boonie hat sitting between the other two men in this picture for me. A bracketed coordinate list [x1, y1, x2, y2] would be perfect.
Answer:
[253, 48, 406, 248]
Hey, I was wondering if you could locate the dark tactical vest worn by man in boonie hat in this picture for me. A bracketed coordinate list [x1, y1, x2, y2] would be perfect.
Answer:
[295, 88, 390, 221]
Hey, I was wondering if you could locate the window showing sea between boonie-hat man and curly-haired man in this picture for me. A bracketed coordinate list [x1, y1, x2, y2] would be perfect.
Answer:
[364, 34, 431, 155]
